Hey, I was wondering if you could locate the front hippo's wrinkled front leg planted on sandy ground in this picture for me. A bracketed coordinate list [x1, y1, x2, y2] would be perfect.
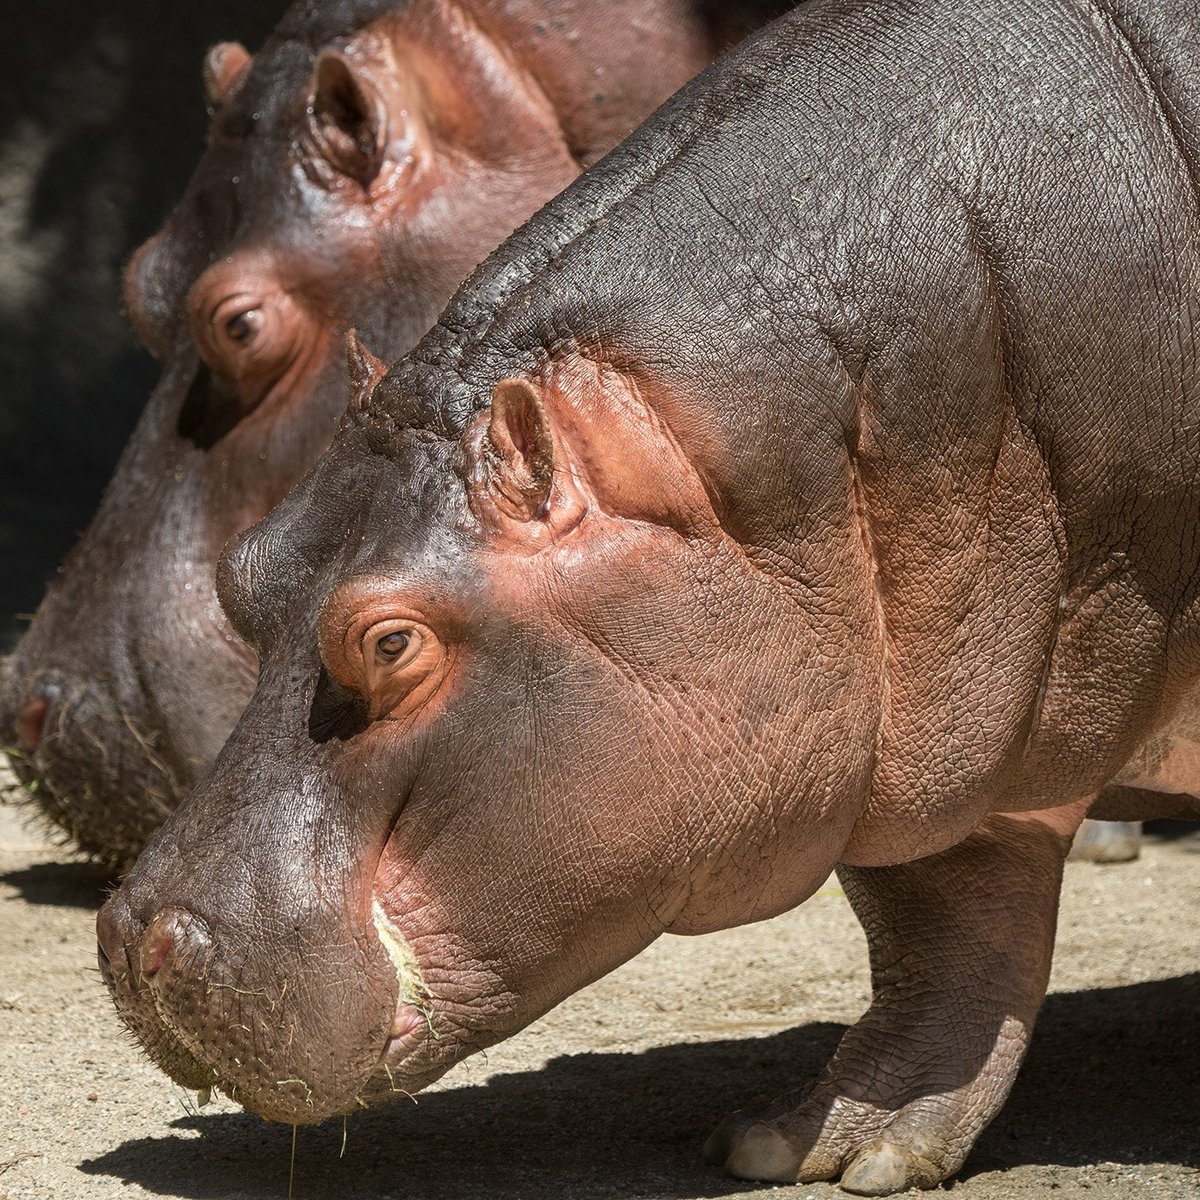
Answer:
[704, 804, 1086, 1195]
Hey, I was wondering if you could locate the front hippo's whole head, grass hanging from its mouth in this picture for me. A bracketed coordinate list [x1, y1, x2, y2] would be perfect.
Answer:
[100, 350, 878, 1122]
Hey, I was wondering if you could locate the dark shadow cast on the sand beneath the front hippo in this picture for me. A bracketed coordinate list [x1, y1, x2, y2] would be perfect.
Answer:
[82, 974, 1200, 1200]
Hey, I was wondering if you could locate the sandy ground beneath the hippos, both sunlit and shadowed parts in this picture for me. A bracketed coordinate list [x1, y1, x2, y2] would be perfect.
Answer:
[0, 777, 1200, 1200]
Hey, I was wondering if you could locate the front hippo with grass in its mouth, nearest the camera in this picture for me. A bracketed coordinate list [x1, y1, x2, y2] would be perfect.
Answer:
[98, 0, 1200, 1195]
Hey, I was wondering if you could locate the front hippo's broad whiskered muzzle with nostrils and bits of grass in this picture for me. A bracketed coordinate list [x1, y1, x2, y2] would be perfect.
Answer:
[97, 705, 412, 1123]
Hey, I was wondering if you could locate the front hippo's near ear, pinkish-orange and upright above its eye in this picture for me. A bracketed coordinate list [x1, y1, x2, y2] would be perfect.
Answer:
[487, 379, 554, 521]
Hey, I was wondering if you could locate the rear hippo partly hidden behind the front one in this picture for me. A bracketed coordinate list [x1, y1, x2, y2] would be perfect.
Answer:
[0, 0, 786, 866]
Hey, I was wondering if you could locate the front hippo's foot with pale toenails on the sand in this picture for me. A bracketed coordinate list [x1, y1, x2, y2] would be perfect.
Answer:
[704, 1082, 970, 1196]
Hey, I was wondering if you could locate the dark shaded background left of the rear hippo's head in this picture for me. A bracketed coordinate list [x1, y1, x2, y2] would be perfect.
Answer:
[0, 0, 286, 650]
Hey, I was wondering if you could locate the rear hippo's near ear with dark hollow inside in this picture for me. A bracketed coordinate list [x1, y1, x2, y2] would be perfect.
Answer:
[308, 50, 388, 187]
